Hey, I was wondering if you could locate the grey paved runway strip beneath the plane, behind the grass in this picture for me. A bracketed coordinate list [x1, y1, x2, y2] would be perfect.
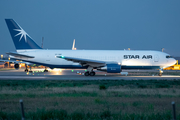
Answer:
[0, 69, 180, 80]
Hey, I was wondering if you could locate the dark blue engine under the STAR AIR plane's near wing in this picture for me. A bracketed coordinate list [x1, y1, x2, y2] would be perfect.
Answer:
[97, 64, 121, 73]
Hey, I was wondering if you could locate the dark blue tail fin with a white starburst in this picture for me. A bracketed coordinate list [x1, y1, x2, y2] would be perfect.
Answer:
[5, 19, 42, 50]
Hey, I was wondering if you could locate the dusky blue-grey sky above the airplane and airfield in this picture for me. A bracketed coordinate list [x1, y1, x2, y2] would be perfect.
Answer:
[0, 0, 180, 56]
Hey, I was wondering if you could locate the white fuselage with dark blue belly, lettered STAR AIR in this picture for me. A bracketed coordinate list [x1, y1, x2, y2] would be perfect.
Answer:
[13, 49, 176, 69]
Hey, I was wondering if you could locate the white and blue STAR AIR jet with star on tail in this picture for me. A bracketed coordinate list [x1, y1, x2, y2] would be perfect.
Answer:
[1, 19, 176, 76]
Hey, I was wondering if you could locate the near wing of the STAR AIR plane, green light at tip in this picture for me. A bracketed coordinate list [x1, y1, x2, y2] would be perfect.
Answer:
[56, 56, 106, 67]
